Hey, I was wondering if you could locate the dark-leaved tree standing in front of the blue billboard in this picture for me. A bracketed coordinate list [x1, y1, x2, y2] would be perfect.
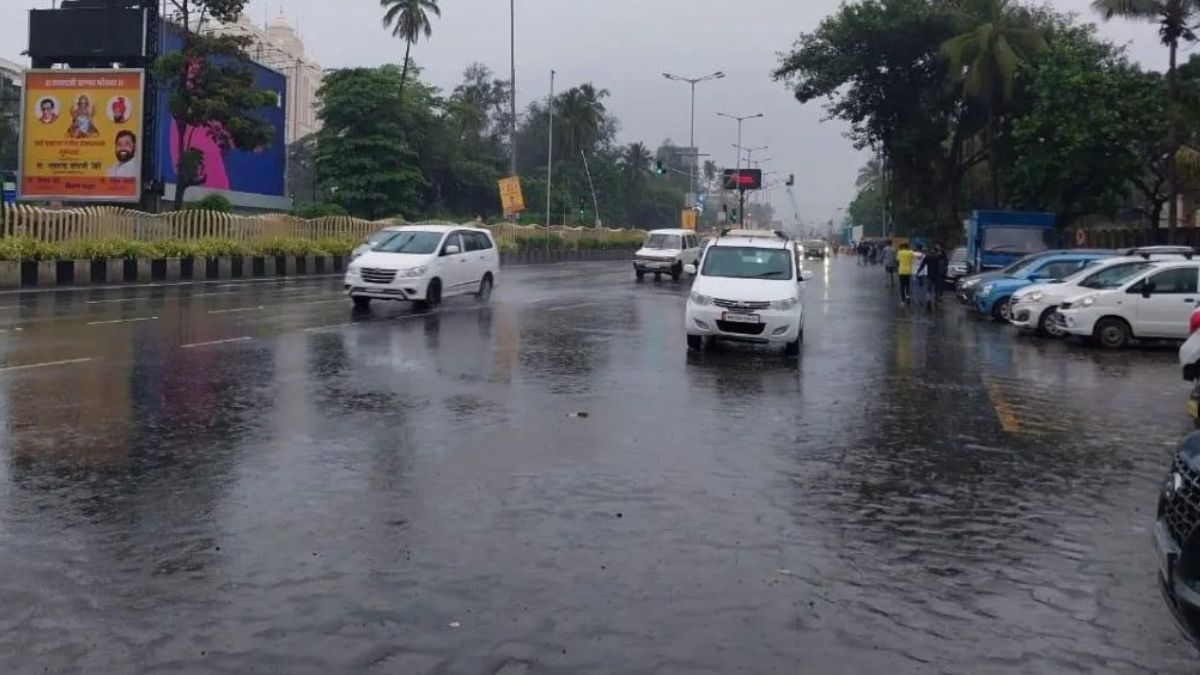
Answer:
[154, 0, 277, 210]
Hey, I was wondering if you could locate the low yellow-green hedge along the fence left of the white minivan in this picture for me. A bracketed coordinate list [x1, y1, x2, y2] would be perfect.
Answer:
[0, 237, 359, 262]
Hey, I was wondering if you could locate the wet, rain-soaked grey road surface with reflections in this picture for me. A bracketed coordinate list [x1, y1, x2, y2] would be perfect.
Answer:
[0, 255, 1200, 675]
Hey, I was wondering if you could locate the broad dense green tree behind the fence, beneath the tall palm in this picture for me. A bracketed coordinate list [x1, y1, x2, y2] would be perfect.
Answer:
[316, 65, 426, 219]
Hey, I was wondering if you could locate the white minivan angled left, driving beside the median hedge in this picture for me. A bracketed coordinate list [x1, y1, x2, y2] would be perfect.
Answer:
[346, 225, 500, 309]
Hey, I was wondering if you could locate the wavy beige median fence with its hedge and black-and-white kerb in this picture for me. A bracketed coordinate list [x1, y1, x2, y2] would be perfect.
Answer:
[0, 204, 644, 289]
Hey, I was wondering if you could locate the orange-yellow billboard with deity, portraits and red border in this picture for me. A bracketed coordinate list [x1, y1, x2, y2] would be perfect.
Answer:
[17, 68, 145, 202]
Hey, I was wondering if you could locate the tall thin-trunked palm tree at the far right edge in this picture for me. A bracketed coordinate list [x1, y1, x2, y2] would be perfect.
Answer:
[1092, 0, 1200, 243]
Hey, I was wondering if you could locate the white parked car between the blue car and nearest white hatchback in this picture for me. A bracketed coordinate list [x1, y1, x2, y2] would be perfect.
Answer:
[1009, 253, 1186, 338]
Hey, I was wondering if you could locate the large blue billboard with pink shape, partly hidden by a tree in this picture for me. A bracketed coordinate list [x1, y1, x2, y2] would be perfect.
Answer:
[155, 24, 292, 210]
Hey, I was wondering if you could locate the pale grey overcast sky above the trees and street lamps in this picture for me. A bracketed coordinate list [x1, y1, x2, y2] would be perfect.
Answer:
[0, 0, 1180, 221]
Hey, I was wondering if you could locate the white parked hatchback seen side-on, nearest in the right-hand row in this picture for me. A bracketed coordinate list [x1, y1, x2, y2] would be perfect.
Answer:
[1058, 261, 1200, 350]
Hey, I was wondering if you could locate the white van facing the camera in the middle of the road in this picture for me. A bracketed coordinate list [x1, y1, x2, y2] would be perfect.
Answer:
[684, 232, 810, 354]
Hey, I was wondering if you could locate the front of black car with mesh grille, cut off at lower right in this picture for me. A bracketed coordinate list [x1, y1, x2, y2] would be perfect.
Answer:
[1152, 431, 1200, 646]
